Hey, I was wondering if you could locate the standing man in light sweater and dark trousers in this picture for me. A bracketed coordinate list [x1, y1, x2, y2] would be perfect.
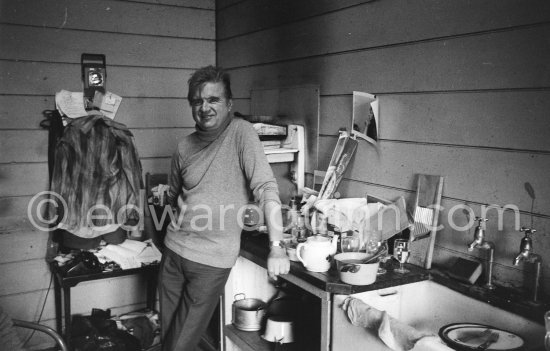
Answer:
[159, 66, 290, 351]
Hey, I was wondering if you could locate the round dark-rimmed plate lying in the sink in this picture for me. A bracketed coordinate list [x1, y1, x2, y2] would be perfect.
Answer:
[439, 323, 525, 351]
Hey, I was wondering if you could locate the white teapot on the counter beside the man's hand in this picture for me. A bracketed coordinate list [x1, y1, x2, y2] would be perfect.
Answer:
[296, 235, 338, 272]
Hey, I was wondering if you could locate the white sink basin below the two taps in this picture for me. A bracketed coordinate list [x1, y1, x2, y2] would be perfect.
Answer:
[333, 280, 545, 351]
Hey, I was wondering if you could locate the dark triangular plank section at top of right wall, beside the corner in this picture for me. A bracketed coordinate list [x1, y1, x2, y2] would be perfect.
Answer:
[216, 0, 374, 40]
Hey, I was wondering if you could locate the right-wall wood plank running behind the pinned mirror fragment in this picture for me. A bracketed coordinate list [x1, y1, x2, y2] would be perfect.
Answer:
[320, 91, 550, 152]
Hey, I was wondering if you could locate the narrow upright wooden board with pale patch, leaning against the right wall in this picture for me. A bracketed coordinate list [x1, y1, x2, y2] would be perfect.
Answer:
[410, 174, 445, 269]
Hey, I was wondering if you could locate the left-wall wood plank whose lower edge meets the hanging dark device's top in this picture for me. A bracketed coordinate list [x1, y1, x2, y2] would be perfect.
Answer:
[0, 25, 215, 69]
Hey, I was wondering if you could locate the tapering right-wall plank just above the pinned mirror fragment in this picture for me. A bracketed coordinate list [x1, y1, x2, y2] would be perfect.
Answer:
[226, 26, 550, 97]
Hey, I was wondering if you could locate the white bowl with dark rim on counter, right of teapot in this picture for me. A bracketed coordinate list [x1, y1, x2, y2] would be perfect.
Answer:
[334, 252, 380, 285]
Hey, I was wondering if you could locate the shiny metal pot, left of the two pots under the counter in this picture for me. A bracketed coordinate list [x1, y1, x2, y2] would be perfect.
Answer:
[231, 293, 267, 331]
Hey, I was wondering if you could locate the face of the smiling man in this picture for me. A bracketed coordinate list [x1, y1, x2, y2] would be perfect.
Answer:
[189, 82, 232, 130]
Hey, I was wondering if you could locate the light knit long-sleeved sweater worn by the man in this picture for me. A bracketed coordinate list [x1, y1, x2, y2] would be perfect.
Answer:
[165, 118, 280, 268]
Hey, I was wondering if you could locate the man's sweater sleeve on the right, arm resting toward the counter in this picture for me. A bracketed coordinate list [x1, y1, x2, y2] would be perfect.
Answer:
[239, 121, 281, 208]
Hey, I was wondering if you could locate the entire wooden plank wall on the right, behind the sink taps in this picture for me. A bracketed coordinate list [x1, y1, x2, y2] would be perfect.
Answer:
[216, 0, 550, 300]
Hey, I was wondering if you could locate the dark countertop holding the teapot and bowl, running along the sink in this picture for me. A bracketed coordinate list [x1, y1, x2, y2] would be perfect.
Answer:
[240, 232, 550, 324]
